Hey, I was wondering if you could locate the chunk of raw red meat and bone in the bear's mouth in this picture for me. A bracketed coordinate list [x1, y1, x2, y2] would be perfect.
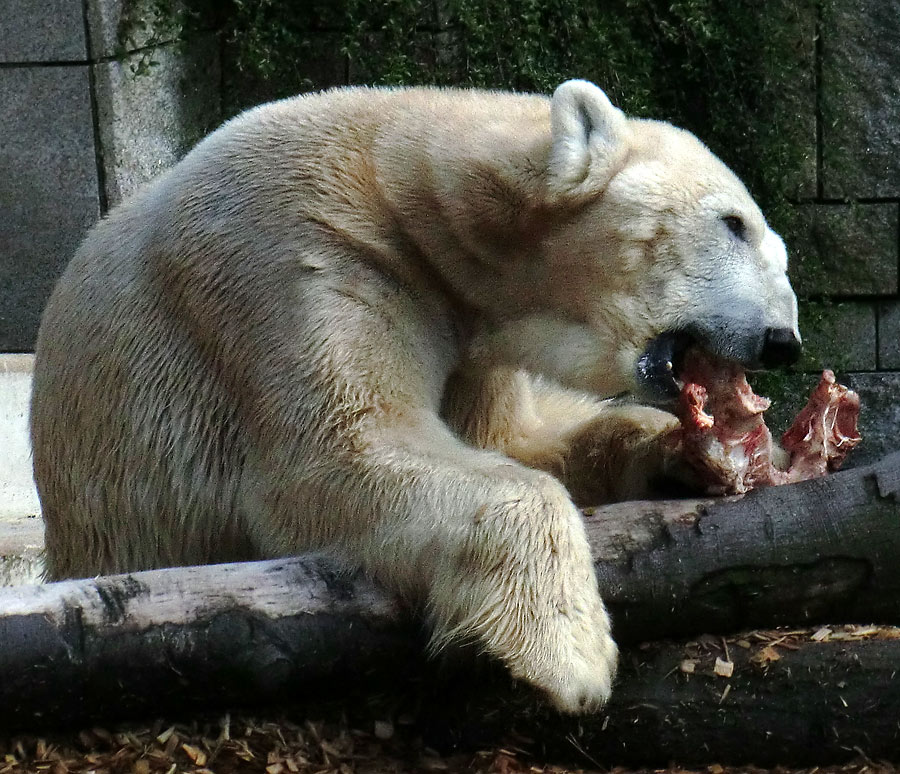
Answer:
[677, 350, 860, 494]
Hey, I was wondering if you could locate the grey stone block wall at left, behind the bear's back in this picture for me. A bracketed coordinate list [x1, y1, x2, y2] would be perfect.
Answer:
[0, 0, 220, 352]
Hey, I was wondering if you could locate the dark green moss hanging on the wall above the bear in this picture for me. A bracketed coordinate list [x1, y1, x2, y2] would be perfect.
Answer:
[157, 0, 817, 218]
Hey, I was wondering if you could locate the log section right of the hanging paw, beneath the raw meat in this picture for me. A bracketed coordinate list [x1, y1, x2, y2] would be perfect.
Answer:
[587, 452, 900, 642]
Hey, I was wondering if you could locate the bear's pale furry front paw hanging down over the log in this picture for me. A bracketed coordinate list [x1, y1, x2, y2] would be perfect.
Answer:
[430, 475, 617, 712]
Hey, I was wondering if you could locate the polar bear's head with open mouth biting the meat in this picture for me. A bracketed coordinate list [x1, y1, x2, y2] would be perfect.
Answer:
[472, 81, 800, 398]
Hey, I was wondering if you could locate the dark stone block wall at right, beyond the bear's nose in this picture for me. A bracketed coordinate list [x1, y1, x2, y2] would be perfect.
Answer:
[776, 0, 900, 463]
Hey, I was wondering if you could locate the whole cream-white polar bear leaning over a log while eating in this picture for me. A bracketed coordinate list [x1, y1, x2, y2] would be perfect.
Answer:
[32, 80, 799, 712]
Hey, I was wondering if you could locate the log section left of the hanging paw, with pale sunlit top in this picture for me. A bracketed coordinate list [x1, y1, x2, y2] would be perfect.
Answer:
[0, 555, 422, 729]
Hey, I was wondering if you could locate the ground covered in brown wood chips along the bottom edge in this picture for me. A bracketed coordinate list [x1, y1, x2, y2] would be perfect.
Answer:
[0, 715, 900, 774]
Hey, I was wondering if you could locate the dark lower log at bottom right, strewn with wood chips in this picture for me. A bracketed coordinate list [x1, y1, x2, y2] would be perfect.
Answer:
[422, 630, 900, 769]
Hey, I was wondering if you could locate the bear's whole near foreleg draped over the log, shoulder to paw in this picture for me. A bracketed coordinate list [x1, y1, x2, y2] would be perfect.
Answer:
[241, 296, 616, 712]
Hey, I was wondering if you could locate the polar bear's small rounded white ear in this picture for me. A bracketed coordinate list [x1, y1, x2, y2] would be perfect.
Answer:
[549, 81, 630, 196]
